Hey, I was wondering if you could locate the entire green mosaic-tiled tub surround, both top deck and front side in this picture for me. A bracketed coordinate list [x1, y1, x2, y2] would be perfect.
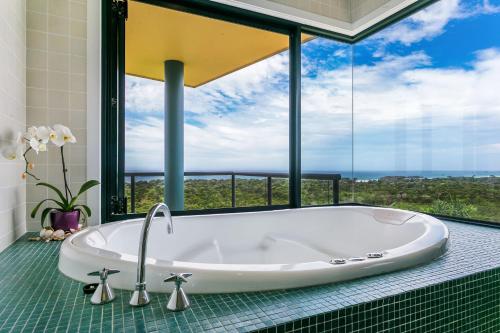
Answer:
[0, 222, 500, 333]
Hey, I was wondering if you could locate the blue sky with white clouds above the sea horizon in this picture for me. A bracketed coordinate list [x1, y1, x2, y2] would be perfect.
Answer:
[126, 0, 500, 173]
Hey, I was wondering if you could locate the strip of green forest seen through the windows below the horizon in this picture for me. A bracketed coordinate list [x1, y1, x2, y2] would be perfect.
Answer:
[125, 176, 500, 222]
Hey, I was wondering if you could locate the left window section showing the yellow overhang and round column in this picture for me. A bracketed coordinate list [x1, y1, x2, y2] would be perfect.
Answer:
[124, 3, 289, 213]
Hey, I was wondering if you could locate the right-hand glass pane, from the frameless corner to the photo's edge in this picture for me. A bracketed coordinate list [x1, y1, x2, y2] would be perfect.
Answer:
[353, 1, 500, 221]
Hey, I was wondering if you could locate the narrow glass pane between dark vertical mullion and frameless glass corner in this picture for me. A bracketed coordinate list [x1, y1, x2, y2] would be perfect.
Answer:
[301, 37, 352, 206]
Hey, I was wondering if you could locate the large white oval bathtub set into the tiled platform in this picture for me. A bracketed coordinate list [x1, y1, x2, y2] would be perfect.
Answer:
[59, 206, 448, 293]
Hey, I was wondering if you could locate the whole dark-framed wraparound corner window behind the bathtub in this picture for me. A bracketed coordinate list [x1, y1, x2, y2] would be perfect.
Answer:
[103, 0, 500, 222]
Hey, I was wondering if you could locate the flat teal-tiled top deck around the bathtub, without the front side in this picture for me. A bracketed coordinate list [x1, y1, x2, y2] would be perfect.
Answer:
[0, 222, 500, 332]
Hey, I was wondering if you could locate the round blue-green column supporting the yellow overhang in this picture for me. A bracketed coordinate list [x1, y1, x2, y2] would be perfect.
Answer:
[164, 60, 184, 210]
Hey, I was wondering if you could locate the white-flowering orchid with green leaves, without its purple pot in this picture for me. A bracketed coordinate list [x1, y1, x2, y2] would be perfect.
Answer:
[3, 124, 99, 228]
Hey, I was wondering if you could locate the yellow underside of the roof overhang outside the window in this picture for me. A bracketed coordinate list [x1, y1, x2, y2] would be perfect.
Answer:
[125, 1, 310, 87]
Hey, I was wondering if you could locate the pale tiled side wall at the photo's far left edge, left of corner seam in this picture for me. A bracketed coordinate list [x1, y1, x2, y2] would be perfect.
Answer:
[0, 0, 26, 251]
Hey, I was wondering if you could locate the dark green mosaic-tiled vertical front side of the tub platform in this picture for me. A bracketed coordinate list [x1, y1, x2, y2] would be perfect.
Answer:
[258, 269, 500, 333]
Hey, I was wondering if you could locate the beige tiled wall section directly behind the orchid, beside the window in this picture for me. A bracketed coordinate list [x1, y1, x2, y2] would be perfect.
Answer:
[25, 0, 87, 230]
